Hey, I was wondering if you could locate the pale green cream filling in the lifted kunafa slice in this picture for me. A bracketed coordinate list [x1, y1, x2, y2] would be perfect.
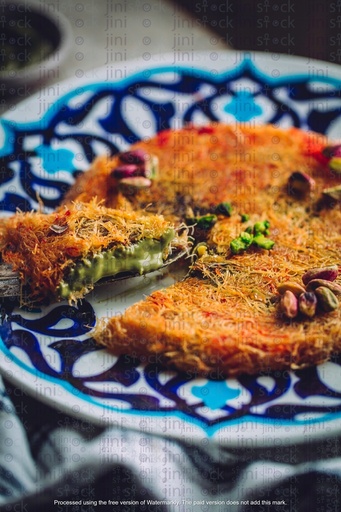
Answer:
[57, 229, 175, 299]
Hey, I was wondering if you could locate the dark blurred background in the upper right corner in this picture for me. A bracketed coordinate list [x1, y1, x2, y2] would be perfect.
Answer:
[177, 0, 341, 64]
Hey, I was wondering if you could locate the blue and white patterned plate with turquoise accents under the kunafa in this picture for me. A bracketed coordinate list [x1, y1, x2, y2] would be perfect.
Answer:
[0, 52, 341, 447]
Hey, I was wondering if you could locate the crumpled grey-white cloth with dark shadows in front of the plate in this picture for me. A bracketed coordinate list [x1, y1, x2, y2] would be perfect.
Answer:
[0, 374, 341, 512]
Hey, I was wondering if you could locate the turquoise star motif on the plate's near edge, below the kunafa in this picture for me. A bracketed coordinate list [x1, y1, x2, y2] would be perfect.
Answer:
[192, 381, 241, 409]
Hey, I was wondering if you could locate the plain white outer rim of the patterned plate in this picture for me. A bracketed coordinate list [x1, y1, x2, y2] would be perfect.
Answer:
[0, 50, 341, 446]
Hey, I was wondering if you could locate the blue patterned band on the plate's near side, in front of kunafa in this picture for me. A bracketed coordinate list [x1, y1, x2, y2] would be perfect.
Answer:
[0, 300, 341, 426]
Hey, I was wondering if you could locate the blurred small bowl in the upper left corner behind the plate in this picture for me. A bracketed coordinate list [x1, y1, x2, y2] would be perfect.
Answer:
[0, 0, 72, 91]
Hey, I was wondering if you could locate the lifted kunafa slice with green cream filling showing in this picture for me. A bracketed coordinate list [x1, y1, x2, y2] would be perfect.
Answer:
[1, 200, 187, 302]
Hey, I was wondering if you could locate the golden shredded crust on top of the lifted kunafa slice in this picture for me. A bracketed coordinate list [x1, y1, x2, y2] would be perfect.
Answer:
[0, 200, 179, 303]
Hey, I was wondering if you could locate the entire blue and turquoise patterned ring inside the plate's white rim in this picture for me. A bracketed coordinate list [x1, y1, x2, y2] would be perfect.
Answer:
[0, 56, 341, 435]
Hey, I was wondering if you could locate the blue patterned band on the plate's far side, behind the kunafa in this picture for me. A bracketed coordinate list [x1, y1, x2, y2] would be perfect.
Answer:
[0, 57, 341, 212]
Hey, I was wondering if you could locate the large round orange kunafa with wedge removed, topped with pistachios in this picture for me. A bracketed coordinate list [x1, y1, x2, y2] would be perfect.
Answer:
[90, 125, 341, 378]
